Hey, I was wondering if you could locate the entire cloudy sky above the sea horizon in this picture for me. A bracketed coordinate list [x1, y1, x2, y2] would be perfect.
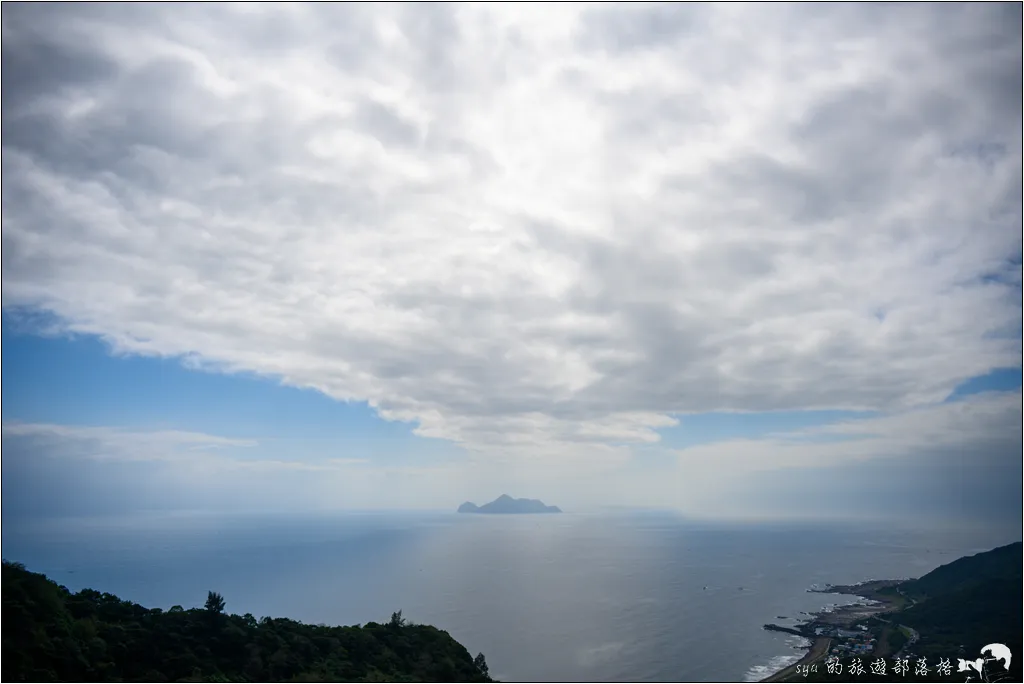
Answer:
[0, 3, 1024, 538]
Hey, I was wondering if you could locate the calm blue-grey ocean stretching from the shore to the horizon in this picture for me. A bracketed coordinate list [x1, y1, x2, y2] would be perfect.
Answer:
[2, 513, 1018, 682]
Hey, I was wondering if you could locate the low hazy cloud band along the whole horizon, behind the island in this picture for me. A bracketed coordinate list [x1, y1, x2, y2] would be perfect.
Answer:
[3, 391, 1024, 537]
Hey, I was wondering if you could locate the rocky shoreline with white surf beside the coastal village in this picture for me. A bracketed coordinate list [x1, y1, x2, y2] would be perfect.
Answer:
[760, 580, 904, 682]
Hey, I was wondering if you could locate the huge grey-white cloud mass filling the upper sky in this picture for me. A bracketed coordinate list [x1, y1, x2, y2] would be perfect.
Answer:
[2, 4, 1022, 468]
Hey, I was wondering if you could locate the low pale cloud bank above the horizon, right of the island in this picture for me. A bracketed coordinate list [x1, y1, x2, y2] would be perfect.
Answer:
[602, 391, 1024, 524]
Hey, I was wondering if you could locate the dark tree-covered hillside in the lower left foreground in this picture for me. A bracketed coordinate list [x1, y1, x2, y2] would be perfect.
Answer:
[0, 560, 493, 682]
